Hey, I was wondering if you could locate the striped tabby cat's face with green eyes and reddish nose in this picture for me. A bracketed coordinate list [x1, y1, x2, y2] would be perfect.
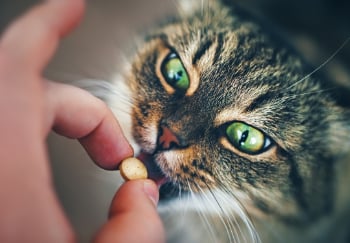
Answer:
[127, 1, 344, 225]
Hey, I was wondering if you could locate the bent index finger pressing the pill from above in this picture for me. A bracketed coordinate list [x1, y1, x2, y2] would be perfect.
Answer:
[46, 82, 133, 169]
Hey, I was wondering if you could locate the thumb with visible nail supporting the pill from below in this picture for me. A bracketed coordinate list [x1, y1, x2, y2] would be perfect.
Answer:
[95, 180, 165, 243]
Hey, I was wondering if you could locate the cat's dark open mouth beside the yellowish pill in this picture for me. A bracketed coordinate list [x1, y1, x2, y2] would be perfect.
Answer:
[137, 152, 179, 201]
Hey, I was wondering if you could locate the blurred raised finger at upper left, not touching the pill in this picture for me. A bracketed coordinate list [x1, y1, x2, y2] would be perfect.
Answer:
[0, 0, 84, 72]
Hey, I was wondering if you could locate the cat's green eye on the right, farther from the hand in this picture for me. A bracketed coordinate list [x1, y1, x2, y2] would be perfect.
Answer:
[226, 122, 271, 154]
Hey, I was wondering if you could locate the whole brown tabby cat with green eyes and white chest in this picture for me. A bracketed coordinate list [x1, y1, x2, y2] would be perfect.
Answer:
[78, 0, 350, 243]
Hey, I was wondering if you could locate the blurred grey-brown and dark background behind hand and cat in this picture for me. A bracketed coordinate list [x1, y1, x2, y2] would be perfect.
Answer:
[0, 0, 350, 242]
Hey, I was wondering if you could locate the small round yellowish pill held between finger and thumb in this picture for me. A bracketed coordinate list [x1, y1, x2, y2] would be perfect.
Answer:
[119, 157, 148, 181]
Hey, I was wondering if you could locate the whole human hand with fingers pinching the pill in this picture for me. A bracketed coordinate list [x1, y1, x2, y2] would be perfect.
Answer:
[0, 0, 164, 242]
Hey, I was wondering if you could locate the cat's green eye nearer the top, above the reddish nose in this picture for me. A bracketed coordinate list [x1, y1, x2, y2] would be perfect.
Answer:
[161, 53, 190, 92]
